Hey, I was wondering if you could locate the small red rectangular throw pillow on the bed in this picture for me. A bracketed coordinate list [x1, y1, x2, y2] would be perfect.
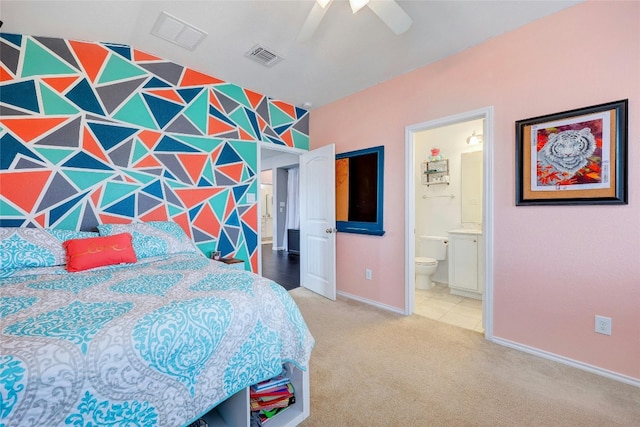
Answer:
[62, 233, 138, 271]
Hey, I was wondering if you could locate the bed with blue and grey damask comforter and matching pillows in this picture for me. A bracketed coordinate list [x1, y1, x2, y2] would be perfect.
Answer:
[0, 223, 314, 427]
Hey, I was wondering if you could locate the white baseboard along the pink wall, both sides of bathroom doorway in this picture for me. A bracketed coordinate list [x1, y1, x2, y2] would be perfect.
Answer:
[336, 291, 640, 388]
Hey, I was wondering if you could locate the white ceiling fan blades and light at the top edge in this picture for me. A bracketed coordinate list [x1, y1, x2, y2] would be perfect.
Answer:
[298, 0, 413, 42]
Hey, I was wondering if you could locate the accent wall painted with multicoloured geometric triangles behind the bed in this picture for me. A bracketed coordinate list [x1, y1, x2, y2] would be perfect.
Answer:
[0, 33, 309, 271]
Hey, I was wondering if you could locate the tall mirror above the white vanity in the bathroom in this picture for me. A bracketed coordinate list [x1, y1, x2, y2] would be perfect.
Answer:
[460, 151, 482, 228]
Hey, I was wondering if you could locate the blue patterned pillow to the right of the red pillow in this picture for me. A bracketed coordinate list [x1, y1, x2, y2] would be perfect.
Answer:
[98, 221, 201, 259]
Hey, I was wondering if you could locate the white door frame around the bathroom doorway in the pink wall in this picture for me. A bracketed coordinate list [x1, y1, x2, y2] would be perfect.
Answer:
[404, 106, 493, 339]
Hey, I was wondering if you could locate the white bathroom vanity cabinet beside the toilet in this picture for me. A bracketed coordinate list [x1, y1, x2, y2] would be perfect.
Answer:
[448, 229, 484, 299]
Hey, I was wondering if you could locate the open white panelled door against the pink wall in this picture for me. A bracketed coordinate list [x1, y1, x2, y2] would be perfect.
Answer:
[300, 144, 336, 301]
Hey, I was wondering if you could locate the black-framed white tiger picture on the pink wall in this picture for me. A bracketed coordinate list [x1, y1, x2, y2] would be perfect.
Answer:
[516, 99, 628, 206]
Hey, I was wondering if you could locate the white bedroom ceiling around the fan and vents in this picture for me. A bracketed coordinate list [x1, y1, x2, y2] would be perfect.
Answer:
[0, 0, 582, 109]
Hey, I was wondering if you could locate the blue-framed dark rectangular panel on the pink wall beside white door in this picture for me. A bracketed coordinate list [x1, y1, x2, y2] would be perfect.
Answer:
[336, 146, 384, 236]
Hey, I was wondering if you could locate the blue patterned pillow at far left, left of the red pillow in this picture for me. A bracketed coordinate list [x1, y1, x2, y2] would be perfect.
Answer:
[0, 227, 98, 270]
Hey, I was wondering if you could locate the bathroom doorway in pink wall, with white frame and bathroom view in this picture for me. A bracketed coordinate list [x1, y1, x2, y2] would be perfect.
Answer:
[405, 108, 493, 337]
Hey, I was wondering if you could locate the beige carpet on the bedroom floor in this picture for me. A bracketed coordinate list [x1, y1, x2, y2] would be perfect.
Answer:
[291, 288, 640, 427]
